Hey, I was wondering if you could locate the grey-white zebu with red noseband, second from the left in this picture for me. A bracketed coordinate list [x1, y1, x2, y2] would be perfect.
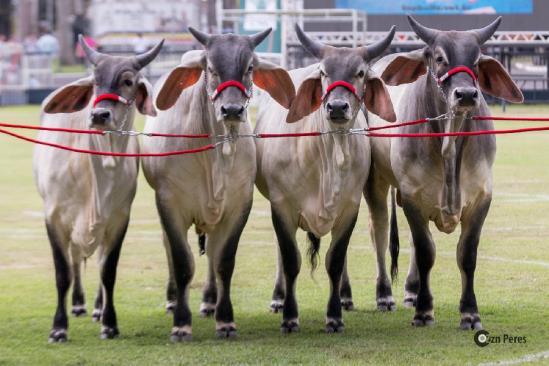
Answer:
[143, 28, 295, 342]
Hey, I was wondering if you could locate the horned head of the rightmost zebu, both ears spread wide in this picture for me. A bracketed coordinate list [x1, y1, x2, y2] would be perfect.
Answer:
[381, 16, 523, 113]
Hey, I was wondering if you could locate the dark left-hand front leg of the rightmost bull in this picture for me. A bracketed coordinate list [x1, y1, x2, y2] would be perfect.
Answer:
[403, 200, 435, 326]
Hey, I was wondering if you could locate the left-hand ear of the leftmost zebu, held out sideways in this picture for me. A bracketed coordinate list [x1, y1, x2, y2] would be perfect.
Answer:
[43, 76, 94, 113]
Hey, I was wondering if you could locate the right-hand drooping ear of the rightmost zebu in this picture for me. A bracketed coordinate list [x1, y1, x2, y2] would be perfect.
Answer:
[478, 55, 524, 103]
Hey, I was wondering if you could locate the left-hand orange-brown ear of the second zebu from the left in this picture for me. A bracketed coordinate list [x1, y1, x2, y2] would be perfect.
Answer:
[156, 50, 205, 111]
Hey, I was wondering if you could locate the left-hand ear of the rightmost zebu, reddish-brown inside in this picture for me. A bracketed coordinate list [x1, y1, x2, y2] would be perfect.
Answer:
[381, 49, 427, 86]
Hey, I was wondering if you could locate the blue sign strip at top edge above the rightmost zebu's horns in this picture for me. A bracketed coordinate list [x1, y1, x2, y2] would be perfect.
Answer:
[335, 0, 534, 14]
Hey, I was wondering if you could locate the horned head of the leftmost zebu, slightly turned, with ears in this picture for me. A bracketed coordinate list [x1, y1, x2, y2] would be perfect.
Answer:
[44, 36, 164, 130]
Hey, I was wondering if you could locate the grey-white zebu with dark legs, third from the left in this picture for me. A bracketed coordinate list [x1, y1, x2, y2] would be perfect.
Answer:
[255, 25, 395, 333]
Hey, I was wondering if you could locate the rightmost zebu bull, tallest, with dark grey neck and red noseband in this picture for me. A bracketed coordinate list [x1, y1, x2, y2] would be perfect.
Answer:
[365, 17, 523, 329]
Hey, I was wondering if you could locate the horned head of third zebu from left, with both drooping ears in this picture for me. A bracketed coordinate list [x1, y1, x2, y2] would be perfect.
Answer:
[286, 25, 396, 125]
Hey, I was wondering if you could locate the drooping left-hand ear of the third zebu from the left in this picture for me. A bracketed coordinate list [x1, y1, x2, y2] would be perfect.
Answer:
[286, 70, 322, 123]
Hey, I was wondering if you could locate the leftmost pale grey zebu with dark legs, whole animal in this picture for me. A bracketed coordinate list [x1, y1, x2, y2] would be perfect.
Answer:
[33, 36, 164, 342]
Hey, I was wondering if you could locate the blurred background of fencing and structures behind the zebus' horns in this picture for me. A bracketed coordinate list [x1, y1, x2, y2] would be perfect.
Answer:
[0, 0, 549, 105]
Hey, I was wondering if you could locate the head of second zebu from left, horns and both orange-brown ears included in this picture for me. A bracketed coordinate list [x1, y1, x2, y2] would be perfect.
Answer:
[156, 27, 295, 124]
